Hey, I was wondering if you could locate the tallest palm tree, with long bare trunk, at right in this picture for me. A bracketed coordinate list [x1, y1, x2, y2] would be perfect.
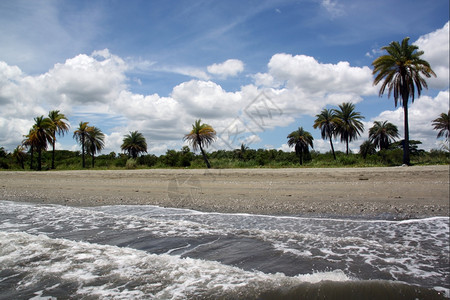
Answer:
[372, 37, 436, 165]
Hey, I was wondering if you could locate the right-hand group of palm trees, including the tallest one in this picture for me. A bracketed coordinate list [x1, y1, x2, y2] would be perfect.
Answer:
[288, 37, 440, 165]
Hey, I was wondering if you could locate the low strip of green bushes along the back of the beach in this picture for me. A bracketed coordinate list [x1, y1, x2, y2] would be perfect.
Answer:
[0, 144, 450, 170]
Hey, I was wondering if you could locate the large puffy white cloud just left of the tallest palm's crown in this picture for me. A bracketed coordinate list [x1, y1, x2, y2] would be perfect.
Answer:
[253, 53, 376, 121]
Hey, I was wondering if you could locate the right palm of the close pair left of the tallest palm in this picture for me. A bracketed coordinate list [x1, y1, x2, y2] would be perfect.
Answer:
[333, 102, 364, 155]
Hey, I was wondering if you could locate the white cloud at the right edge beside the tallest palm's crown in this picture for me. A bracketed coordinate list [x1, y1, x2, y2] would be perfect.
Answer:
[413, 22, 450, 89]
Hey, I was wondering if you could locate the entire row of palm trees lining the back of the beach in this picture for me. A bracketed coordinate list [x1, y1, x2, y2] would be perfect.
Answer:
[2, 38, 450, 170]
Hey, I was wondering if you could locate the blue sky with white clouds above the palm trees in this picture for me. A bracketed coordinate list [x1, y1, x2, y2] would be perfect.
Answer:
[0, 0, 449, 155]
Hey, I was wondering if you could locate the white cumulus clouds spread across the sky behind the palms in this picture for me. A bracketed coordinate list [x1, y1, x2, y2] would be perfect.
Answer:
[0, 23, 449, 154]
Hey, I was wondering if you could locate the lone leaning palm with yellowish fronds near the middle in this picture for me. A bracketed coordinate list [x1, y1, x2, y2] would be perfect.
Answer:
[183, 119, 216, 169]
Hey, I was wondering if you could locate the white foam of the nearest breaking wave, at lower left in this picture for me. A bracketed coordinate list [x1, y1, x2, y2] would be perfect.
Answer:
[0, 232, 350, 299]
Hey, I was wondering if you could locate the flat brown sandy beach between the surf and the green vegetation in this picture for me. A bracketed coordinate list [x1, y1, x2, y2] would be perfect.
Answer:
[0, 166, 449, 219]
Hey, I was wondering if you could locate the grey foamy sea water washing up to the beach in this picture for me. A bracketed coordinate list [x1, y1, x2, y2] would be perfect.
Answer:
[0, 201, 450, 299]
